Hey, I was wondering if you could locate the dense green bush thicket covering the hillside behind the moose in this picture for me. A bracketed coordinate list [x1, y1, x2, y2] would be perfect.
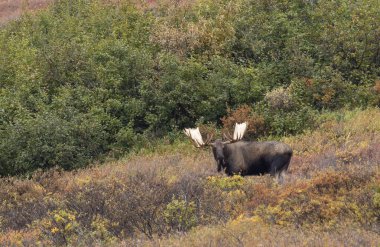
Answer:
[0, 0, 380, 176]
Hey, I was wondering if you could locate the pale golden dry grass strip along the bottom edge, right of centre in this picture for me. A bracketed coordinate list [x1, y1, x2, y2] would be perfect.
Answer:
[132, 221, 380, 247]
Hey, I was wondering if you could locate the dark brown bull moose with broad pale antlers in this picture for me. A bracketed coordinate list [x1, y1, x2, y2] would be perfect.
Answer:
[184, 122, 293, 180]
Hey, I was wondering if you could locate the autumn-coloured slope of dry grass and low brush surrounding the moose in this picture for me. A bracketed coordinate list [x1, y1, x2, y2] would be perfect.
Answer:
[0, 109, 380, 246]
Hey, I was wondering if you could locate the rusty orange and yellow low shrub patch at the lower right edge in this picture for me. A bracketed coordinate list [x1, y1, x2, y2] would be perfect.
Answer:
[251, 169, 377, 228]
